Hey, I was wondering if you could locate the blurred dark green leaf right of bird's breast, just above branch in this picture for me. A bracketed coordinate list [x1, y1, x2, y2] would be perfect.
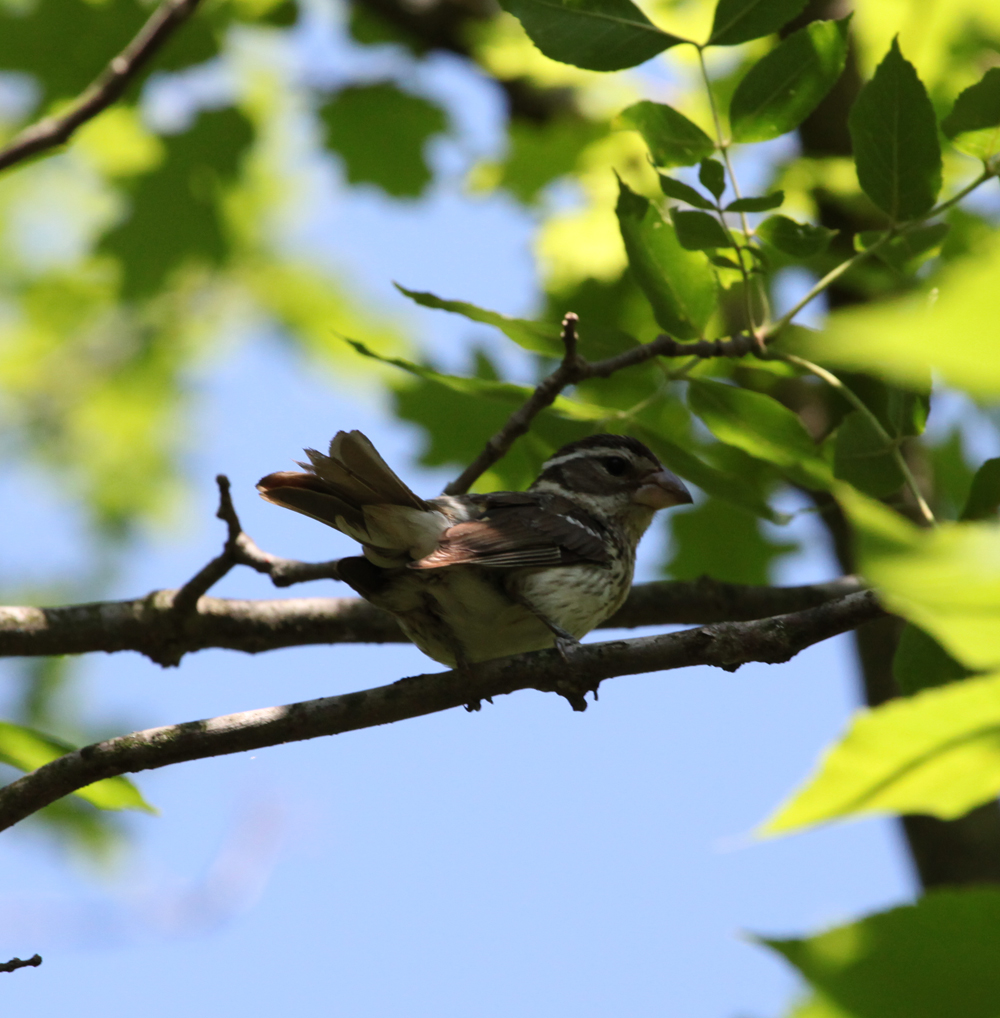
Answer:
[666, 499, 798, 583]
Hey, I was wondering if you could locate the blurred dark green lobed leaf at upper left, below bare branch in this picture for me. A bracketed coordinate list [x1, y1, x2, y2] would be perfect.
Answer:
[101, 109, 254, 299]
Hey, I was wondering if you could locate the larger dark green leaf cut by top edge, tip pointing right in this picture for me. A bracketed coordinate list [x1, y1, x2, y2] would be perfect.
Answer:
[501, 0, 686, 70]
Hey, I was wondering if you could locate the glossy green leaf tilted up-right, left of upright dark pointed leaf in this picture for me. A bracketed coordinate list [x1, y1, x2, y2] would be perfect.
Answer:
[729, 16, 850, 142]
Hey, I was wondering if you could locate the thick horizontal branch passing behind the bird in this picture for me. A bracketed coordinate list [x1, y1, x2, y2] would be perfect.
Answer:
[0, 578, 860, 665]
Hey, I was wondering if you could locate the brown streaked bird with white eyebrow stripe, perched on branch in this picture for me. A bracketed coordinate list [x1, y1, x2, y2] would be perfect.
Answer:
[257, 432, 691, 668]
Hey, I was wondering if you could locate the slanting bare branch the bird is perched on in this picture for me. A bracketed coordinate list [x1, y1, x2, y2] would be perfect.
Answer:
[0, 590, 884, 830]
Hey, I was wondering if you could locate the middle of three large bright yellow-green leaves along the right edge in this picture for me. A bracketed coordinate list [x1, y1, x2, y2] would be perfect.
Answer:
[835, 486, 1000, 671]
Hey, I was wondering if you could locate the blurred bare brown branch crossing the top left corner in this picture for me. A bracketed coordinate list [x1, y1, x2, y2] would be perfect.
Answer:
[0, 0, 201, 170]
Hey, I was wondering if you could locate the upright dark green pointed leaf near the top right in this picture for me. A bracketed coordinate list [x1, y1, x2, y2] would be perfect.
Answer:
[848, 39, 941, 223]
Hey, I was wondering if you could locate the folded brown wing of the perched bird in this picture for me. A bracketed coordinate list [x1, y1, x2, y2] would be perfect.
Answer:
[409, 492, 609, 569]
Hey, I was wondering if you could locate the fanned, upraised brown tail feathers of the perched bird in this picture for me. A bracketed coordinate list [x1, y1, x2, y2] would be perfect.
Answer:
[257, 432, 430, 542]
